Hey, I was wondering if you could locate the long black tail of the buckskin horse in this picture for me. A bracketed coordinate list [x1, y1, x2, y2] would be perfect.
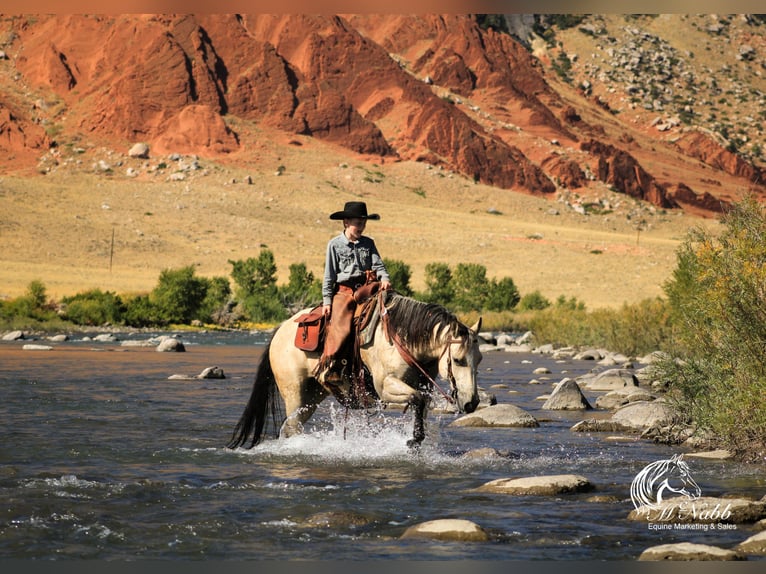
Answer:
[231, 343, 284, 448]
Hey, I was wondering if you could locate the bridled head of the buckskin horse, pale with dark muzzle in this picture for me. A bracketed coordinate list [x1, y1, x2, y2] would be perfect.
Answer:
[439, 318, 482, 413]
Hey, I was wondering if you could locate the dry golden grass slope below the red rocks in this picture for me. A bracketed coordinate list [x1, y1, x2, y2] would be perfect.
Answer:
[0, 120, 717, 308]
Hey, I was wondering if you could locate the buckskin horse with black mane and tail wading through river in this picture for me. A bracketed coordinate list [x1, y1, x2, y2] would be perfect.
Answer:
[227, 291, 482, 449]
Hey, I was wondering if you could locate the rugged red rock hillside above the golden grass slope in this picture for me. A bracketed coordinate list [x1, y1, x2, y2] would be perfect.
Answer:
[0, 14, 766, 214]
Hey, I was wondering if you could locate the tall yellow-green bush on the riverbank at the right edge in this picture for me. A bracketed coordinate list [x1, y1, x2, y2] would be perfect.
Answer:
[660, 197, 766, 459]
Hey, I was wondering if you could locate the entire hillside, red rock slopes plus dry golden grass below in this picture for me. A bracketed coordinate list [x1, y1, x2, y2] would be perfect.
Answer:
[0, 14, 766, 308]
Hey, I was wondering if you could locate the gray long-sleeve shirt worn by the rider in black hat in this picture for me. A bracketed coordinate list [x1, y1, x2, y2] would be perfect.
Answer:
[322, 233, 389, 305]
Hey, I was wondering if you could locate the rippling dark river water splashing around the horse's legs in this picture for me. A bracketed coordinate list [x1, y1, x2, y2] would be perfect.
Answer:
[0, 333, 766, 561]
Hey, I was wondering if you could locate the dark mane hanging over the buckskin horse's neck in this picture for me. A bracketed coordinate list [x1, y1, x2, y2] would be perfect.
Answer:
[386, 292, 469, 353]
